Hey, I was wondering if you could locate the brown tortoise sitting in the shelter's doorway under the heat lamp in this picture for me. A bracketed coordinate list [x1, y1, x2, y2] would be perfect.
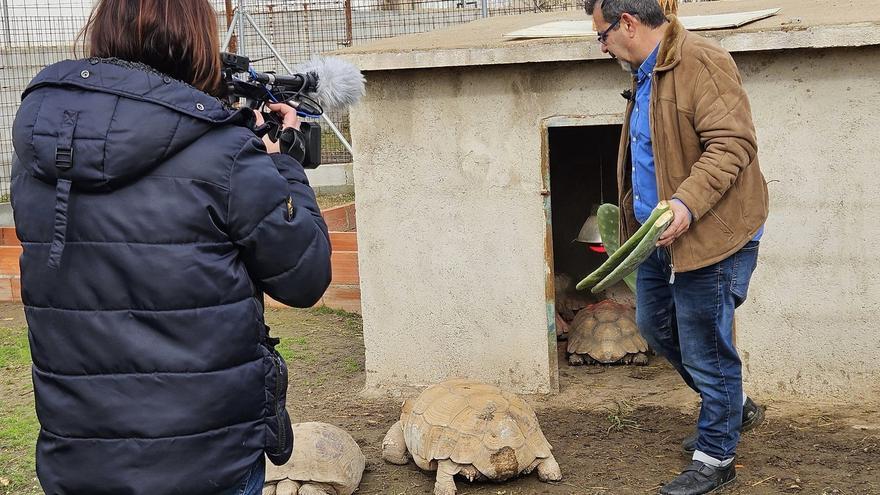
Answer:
[568, 299, 648, 366]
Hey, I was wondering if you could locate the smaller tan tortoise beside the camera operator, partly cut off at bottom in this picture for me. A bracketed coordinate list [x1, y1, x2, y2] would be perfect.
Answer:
[263, 422, 366, 495]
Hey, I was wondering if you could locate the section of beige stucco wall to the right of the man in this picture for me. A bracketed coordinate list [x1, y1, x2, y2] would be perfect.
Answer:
[737, 47, 880, 402]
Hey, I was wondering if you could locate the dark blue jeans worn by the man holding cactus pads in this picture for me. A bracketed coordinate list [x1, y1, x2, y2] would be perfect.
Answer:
[636, 241, 758, 461]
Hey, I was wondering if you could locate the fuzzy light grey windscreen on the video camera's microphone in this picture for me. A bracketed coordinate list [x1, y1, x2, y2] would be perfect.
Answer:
[295, 57, 366, 110]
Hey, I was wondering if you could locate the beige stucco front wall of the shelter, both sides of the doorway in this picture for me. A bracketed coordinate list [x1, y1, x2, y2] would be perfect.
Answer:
[352, 47, 880, 399]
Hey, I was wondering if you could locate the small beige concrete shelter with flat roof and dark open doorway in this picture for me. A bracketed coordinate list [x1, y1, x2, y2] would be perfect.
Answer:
[337, 0, 880, 401]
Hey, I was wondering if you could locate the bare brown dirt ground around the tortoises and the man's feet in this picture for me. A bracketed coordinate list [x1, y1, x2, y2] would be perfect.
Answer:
[0, 305, 880, 495]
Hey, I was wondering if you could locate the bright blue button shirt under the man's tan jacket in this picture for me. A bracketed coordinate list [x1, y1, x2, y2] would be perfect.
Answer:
[629, 44, 764, 241]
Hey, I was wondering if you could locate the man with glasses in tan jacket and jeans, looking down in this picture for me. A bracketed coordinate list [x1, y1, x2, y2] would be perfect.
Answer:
[585, 0, 768, 495]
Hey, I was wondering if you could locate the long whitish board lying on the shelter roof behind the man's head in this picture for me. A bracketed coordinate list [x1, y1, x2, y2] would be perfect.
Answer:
[503, 8, 782, 38]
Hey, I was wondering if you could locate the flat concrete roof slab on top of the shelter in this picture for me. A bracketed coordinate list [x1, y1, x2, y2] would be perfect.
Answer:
[333, 0, 880, 72]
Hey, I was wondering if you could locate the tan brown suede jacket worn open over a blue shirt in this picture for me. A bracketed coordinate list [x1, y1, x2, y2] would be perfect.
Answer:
[617, 16, 768, 272]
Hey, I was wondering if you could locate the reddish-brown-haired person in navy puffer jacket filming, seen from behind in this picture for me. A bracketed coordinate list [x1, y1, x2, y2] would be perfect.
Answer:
[12, 0, 330, 495]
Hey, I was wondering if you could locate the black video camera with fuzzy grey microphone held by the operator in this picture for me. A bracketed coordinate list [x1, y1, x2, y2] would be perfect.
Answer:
[220, 52, 364, 168]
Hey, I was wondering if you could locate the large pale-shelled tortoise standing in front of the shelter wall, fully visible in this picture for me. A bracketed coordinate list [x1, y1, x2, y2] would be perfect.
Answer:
[382, 379, 562, 495]
